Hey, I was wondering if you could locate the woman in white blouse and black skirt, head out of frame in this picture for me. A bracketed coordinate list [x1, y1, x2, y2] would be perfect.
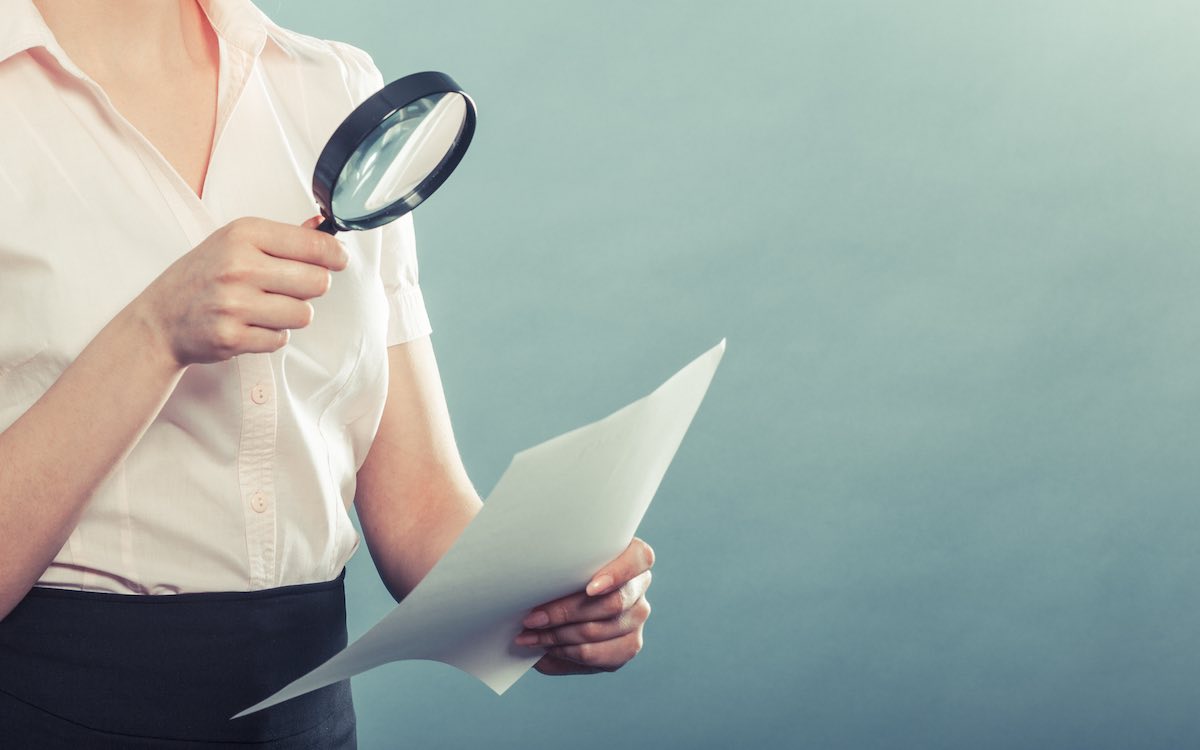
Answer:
[0, 0, 653, 748]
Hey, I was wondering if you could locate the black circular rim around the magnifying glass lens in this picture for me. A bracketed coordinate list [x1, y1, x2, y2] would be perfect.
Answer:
[312, 71, 475, 232]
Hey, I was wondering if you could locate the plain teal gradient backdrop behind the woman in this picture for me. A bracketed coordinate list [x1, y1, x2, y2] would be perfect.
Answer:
[270, 0, 1200, 749]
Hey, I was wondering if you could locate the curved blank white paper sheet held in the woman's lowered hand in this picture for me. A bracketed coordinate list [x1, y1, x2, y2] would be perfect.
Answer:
[233, 338, 725, 719]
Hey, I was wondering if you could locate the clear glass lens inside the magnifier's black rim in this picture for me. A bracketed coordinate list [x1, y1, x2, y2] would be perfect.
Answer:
[332, 91, 467, 221]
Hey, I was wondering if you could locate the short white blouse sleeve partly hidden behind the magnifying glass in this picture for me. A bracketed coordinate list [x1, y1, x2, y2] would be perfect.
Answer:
[330, 42, 433, 347]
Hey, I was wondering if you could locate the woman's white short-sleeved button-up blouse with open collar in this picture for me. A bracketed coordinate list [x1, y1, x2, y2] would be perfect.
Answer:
[0, 0, 430, 594]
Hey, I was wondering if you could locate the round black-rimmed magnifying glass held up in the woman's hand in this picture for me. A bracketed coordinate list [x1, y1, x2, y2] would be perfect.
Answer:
[312, 72, 475, 234]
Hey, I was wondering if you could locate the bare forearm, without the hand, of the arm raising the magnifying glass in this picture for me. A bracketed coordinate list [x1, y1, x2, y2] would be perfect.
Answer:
[0, 302, 184, 619]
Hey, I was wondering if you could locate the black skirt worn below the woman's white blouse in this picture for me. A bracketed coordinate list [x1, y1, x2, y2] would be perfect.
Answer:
[0, 570, 356, 750]
